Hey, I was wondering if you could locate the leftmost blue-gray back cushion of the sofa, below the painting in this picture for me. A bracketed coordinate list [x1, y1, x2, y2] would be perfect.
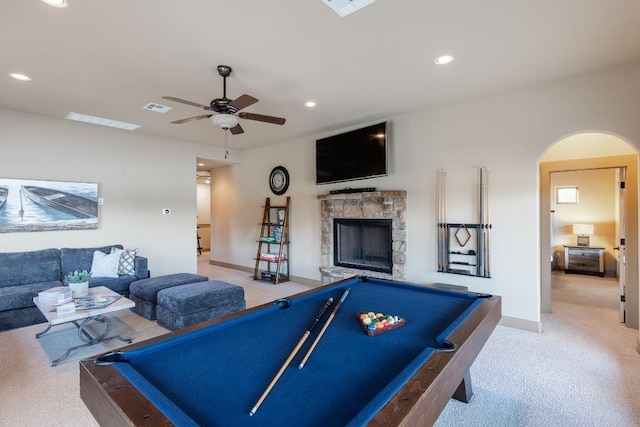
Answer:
[0, 249, 61, 287]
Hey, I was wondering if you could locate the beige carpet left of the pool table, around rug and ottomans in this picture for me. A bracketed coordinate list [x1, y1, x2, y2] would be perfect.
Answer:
[0, 253, 311, 427]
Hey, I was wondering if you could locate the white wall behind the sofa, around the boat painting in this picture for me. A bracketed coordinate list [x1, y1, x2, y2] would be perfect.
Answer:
[0, 110, 237, 276]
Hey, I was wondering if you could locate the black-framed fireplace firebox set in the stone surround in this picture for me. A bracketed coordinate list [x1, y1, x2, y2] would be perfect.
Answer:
[333, 218, 393, 273]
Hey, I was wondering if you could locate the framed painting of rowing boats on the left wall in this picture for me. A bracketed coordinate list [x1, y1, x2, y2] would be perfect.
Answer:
[0, 178, 98, 233]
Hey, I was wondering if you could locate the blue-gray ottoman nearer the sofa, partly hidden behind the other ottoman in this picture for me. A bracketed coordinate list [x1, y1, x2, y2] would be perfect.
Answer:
[129, 273, 209, 320]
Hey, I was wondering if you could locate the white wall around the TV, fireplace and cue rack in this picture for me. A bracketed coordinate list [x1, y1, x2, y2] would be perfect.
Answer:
[211, 63, 640, 329]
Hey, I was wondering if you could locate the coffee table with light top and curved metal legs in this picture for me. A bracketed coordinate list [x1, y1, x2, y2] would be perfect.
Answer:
[33, 286, 136, 366]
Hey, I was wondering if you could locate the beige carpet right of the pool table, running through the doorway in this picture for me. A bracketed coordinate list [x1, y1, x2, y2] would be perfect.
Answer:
[436, 273, 640, 427]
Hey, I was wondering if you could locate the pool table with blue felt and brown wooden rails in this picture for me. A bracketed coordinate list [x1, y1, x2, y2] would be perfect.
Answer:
[80, 276, 501, 427]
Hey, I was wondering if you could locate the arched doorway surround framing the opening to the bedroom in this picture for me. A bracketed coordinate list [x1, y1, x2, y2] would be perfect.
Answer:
[540, 132, 638, 328]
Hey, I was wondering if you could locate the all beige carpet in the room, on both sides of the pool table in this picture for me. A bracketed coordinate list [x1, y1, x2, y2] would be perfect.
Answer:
[0, 260, 640, 427]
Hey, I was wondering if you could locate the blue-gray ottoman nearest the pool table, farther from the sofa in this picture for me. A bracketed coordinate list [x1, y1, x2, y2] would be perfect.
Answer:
[156, 280, 246, 331]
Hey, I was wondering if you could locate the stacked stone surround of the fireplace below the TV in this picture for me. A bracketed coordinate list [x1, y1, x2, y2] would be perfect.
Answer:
[318, 190, 407, 283]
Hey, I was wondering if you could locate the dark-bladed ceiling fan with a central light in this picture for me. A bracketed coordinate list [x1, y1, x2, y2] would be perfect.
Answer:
[162, 65, 286, 135]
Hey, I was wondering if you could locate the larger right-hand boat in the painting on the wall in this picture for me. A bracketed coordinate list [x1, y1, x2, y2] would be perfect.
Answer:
[22, 185, 98, 218]
